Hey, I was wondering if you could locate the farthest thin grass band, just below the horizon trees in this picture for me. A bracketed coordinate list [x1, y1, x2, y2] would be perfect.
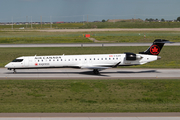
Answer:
[0, 22, 180, 30]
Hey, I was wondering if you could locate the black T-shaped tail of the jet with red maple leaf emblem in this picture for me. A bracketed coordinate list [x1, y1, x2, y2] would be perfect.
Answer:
[139, 39, 172, 55]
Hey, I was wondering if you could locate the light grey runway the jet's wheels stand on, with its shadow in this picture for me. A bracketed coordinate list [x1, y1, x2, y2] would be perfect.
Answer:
[0, 68, 180, 80]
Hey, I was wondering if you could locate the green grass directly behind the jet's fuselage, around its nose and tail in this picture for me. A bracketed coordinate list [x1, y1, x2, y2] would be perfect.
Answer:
[0, 46, 180, 68]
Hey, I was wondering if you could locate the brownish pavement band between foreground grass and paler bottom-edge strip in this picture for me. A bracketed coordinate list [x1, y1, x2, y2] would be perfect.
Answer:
[0, 112, 180, 118]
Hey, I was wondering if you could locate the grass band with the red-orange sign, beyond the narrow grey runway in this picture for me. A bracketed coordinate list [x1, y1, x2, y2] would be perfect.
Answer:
[0, 31, 180, 44]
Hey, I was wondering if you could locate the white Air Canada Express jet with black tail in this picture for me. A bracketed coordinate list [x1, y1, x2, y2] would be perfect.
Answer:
[5, 39, 170, 74]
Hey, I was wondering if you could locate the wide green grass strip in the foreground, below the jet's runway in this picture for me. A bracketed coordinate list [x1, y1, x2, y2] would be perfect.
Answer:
[0, 79, 180, 113]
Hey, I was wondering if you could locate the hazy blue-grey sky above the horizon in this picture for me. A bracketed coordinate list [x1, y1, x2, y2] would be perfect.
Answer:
[0, 0, 180, 22]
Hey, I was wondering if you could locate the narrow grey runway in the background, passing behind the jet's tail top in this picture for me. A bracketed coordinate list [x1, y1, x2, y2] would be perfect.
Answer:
[0, 42, 180, 48]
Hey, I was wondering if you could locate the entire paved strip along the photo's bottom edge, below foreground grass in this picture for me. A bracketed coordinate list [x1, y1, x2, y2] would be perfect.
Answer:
[0, 112, 180, 120]
